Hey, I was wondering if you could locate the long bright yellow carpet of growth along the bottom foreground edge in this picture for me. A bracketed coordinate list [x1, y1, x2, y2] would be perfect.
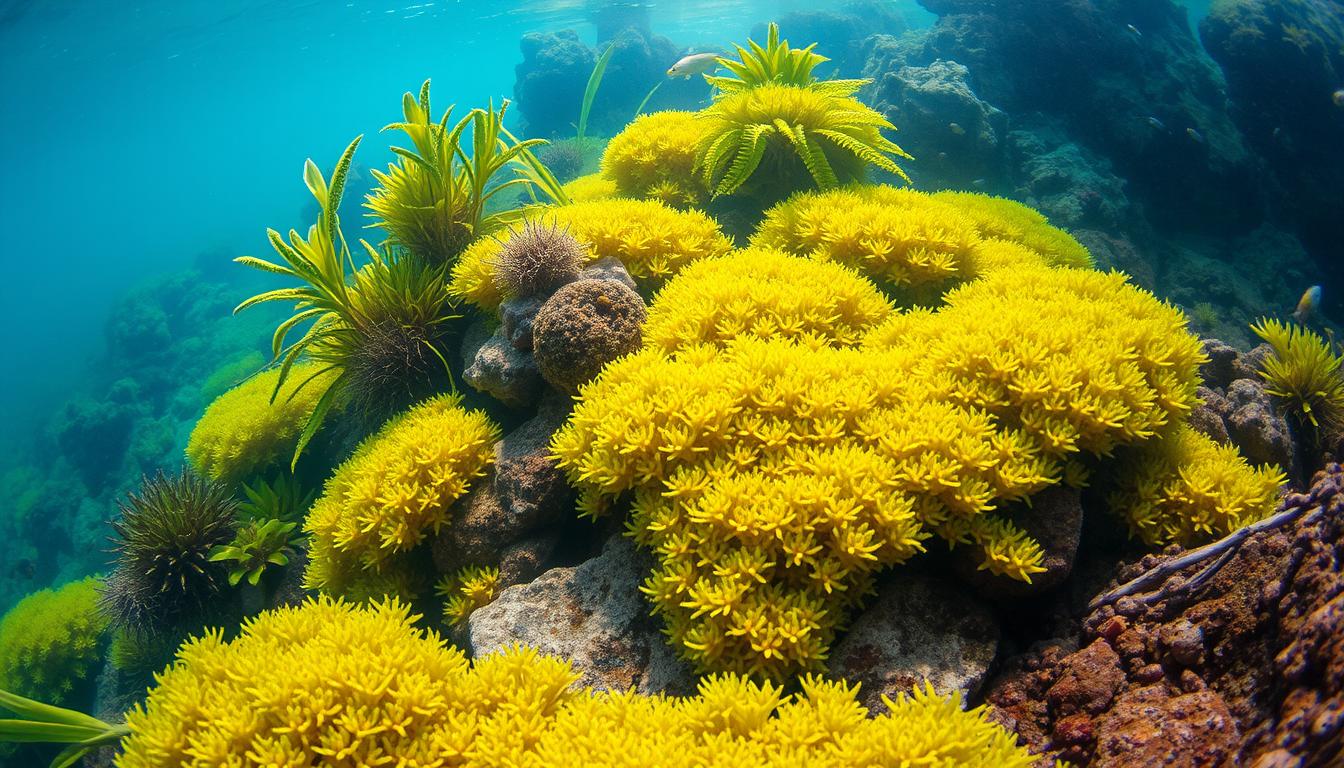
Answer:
[117, 597, 1035, 768]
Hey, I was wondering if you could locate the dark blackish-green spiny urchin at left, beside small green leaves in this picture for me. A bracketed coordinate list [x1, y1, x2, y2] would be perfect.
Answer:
[101, 471, 237, 629]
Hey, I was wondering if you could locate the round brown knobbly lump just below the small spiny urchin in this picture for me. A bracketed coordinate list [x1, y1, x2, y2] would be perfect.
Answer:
[532, 278, 645, 393]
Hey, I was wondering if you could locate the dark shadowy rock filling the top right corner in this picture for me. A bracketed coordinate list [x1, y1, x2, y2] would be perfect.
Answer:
[1199, 0, 1344, 260]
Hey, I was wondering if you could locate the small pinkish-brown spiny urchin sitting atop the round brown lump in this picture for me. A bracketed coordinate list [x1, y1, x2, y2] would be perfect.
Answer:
[495, 222, 586, 297]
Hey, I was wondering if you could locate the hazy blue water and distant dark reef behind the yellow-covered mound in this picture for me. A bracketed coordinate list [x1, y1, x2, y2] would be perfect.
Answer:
[0, 0, 1344, 611]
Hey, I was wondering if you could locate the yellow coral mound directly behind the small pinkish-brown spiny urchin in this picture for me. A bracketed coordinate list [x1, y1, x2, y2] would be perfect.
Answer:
[449, 198, 732, 311]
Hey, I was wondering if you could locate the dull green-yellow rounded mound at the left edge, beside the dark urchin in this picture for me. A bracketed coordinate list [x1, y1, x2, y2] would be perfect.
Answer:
[0, 577, 108, 706]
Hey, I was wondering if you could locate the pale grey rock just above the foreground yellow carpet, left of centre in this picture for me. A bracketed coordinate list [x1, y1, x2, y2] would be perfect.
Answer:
[469, 535, 695, 694]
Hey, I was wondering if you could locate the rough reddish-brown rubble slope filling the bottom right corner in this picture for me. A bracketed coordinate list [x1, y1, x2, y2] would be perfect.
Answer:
[986, 464, 1344, 768]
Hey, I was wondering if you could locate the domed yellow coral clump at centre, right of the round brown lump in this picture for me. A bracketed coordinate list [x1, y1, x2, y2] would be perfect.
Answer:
[644, 247, 891, 352]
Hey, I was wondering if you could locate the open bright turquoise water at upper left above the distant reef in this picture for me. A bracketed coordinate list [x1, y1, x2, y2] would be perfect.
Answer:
[0, 0, 923, 456]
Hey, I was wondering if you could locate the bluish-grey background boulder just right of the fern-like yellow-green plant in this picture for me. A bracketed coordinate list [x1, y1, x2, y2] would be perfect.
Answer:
[864, 56, 1008, 188]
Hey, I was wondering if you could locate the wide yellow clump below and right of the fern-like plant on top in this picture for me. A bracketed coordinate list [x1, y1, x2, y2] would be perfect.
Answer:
[751, 186, 1091, 295]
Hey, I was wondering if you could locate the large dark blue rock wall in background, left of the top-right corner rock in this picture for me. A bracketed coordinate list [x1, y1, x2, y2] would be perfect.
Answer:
[890, 0, 1257, 231]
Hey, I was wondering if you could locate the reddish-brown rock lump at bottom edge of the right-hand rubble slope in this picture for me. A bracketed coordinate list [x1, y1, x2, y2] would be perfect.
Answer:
[1091, 685, 1241, 768]
